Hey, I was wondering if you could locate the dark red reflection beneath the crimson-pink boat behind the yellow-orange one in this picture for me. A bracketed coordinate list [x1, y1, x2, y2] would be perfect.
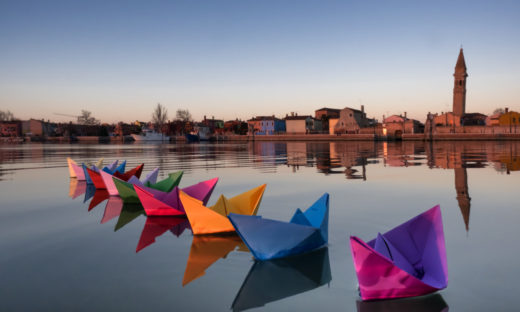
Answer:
[135, 217, 190, 252]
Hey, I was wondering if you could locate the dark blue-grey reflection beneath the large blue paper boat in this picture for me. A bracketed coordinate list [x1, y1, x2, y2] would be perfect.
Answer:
[231, 247, 332, 311]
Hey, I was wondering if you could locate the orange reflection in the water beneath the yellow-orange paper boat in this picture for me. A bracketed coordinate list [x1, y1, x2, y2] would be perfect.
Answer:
[182, 235, 248, 286]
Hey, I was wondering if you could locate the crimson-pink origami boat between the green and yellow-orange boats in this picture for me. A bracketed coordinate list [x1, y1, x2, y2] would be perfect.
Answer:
[134, 178, 218, 216]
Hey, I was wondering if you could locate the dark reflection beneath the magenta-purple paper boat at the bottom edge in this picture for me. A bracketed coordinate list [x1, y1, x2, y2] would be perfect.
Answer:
[357, 294, 449, 312]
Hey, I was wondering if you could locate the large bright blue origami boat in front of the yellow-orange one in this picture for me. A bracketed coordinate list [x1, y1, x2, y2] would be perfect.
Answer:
[229, 193, 329, 260]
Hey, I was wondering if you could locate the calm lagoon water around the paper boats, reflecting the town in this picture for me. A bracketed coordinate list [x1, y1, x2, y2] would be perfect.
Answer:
[0, 142, 520, 311]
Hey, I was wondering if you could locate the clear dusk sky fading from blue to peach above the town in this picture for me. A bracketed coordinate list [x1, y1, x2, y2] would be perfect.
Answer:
[0, 0, 520, 123]
